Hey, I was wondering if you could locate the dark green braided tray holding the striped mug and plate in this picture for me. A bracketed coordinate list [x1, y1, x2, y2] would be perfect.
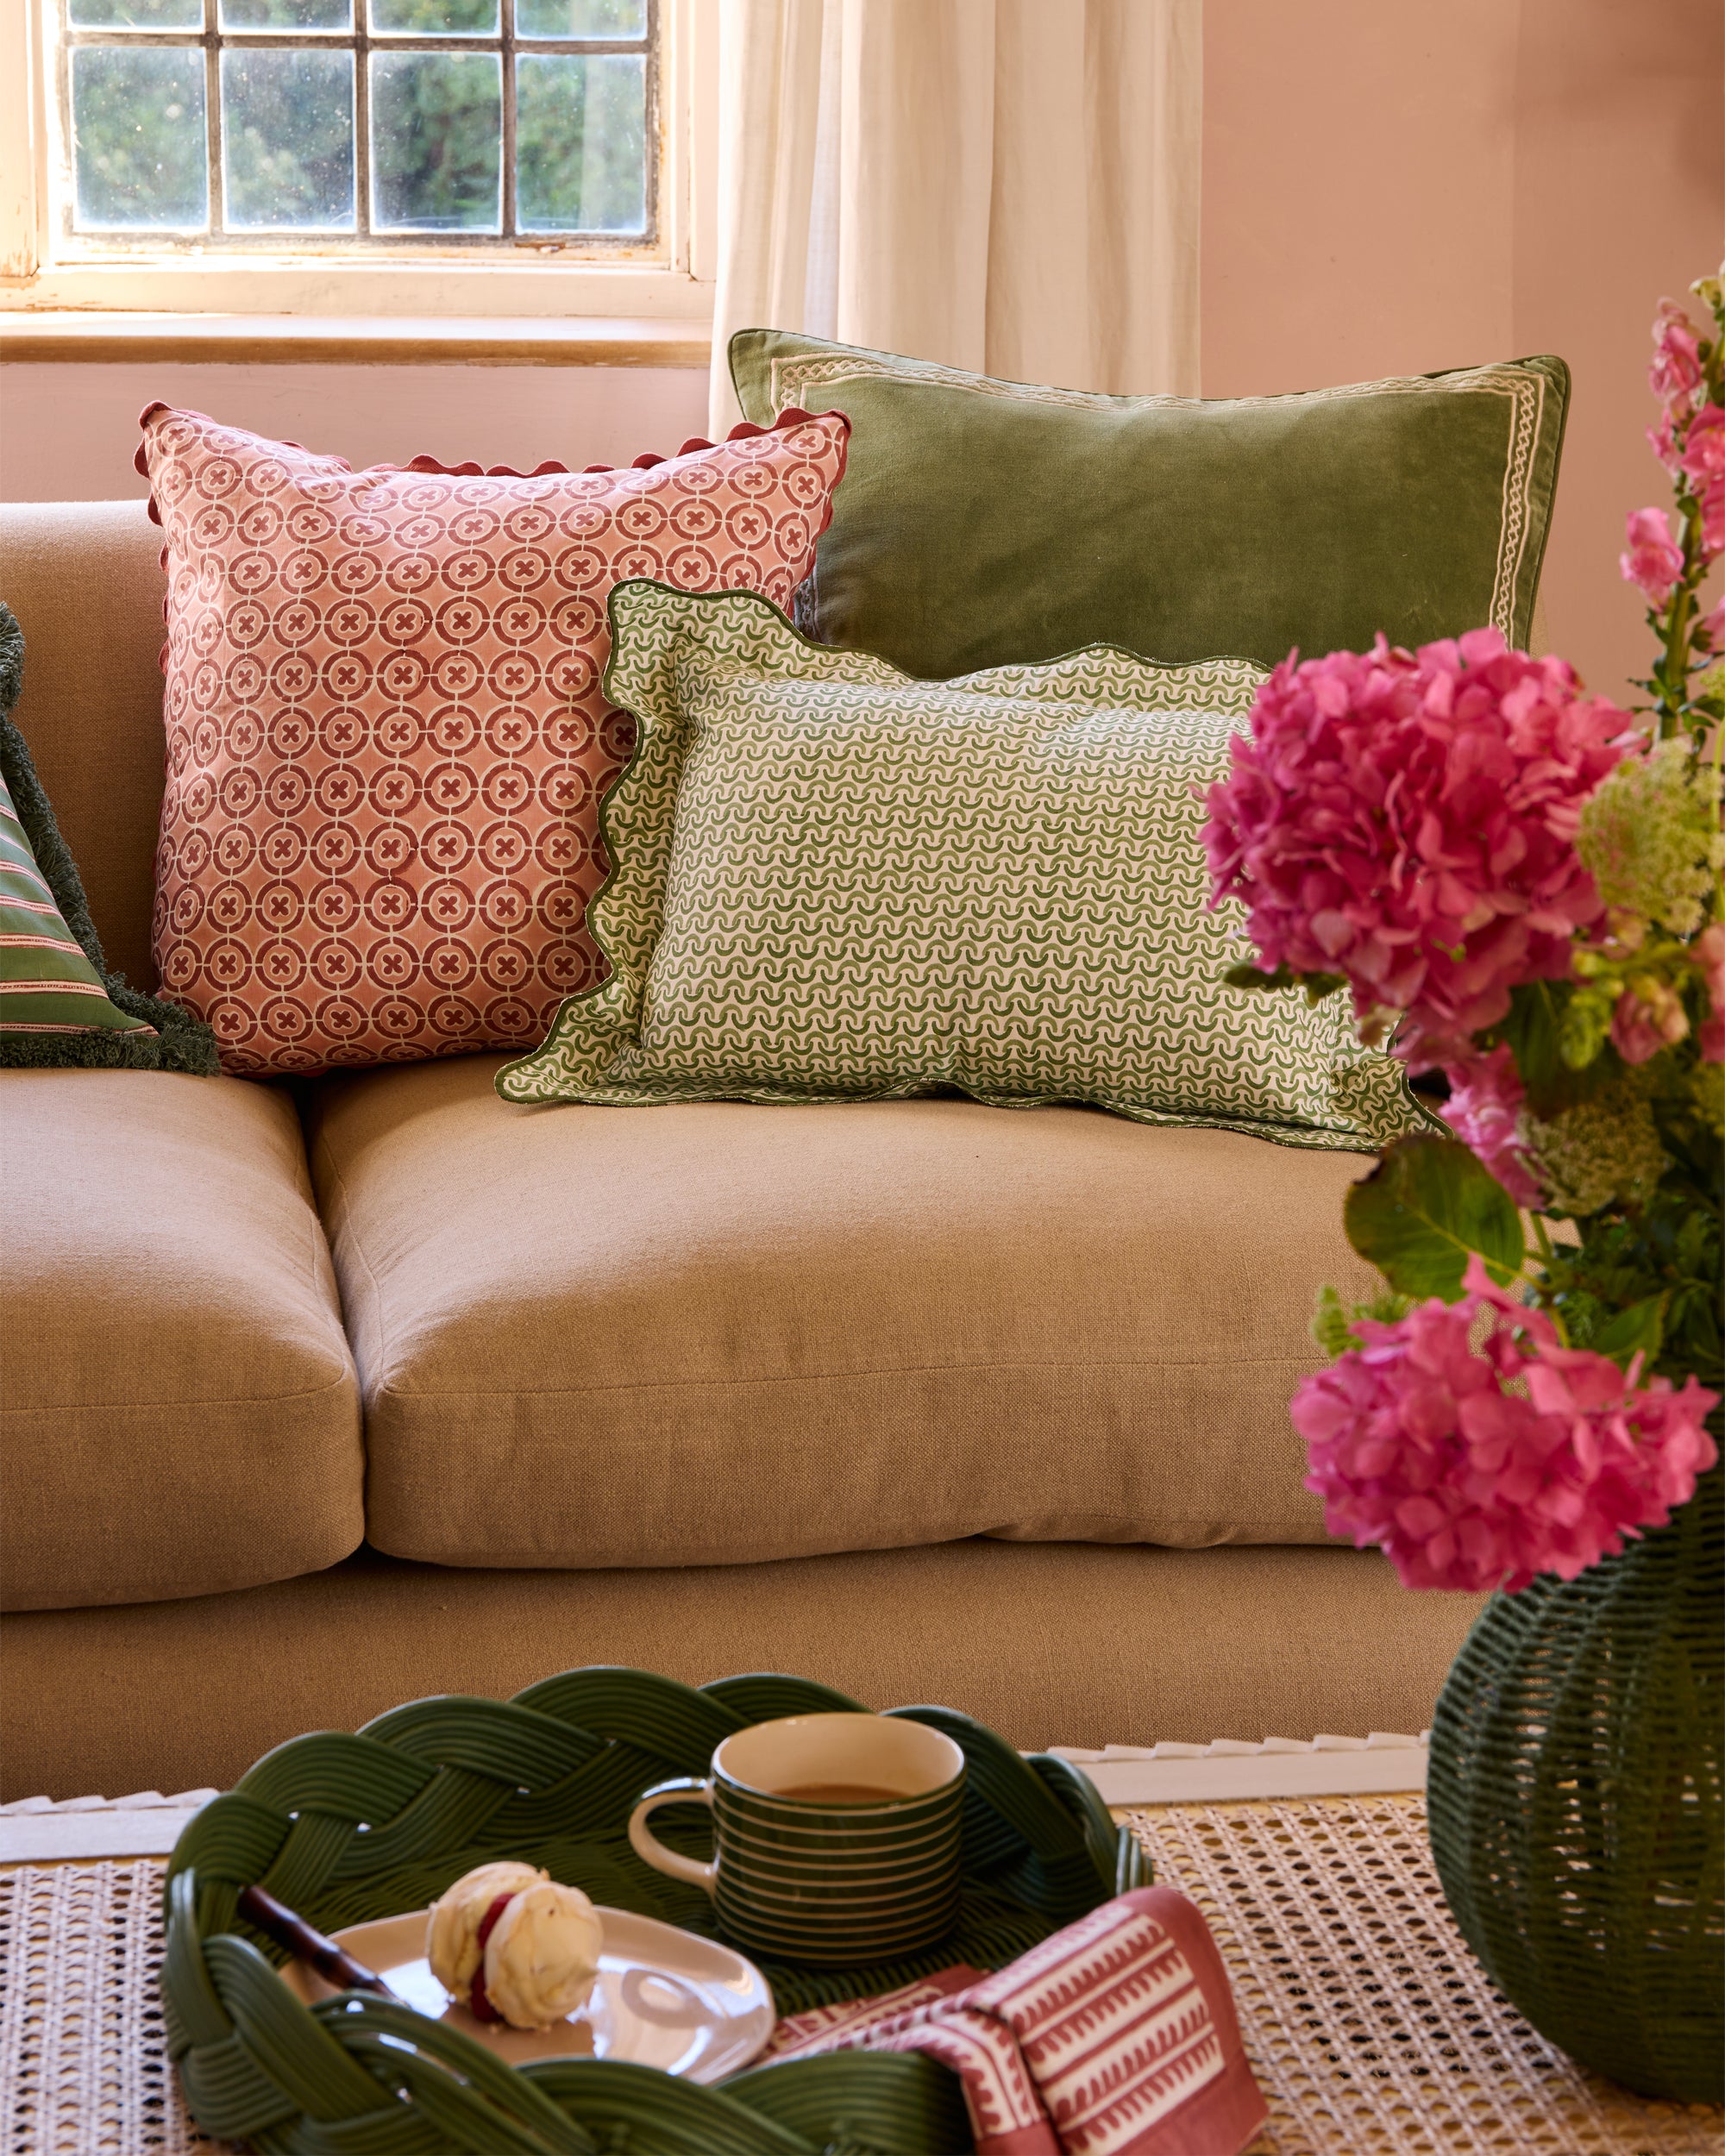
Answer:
[162, 1669, 1150, 2156]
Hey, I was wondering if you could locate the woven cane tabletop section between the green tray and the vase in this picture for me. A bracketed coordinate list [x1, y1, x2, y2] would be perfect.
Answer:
[1126, 1796, 1725, 2156]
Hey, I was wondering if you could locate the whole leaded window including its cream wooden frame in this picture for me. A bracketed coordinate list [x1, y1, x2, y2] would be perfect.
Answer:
[0, 0, 712, 319]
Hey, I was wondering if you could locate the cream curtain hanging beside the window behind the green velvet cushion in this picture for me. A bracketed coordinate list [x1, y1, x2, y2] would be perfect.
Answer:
[712, 0, 1203, 436]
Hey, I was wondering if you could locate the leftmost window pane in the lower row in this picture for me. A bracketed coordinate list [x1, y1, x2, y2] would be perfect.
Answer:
[72, 46, 210, 233]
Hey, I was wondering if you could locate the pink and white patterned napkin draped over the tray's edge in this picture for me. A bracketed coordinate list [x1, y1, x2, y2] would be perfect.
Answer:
[766, 1887, 1266, 2156]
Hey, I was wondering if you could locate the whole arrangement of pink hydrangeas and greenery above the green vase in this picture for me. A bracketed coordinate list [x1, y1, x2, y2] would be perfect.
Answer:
[1203, 272, 1725, 1591]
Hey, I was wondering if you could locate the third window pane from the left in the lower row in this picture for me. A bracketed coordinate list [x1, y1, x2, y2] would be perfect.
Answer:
[371, 52, 503, 233]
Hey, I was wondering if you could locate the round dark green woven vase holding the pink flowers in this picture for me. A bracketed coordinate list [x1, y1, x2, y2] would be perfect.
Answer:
[1427, 1466, 1725, 2103]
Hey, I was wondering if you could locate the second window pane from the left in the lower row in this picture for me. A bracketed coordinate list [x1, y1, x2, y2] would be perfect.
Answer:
[223, 46, 354, 233]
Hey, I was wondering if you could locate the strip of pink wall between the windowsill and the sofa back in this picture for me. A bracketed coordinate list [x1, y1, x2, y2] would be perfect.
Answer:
[0, 362, 707, 503]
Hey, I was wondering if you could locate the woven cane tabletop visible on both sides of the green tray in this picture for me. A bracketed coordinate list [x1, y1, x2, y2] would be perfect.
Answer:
[0, 1796, 1725, 2156]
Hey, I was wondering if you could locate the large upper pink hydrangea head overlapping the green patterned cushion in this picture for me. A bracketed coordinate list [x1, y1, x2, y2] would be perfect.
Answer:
[1203, 630, 1630, 1068]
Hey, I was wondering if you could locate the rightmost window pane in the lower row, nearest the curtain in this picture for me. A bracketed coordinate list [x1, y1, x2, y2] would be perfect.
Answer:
[516, 52, 647, 233]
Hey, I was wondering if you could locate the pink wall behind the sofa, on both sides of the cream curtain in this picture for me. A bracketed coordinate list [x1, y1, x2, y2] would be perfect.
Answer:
[0, 0, 1725, 694]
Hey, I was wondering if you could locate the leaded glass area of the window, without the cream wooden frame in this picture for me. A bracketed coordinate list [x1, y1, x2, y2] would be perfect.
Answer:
[59, 0, 658, 253]
